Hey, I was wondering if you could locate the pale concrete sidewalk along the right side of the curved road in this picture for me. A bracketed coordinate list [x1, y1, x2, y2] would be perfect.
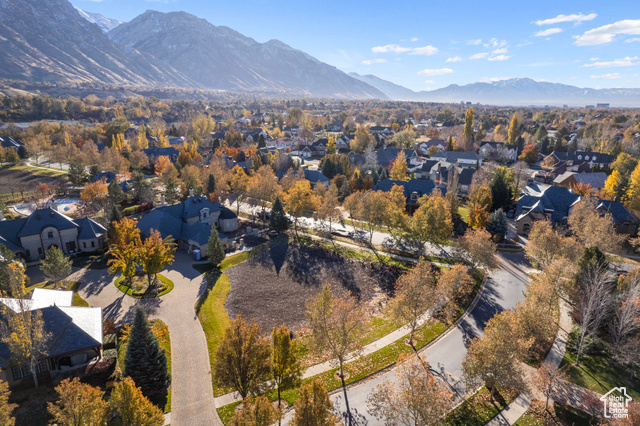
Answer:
[487, 299, 571, 426]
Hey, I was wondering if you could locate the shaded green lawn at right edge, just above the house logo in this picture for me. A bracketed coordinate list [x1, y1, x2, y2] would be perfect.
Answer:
[561, 351, 640, 400]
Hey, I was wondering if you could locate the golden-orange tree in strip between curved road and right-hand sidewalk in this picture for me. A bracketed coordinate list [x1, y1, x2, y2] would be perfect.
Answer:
[462, 311, 531, 400]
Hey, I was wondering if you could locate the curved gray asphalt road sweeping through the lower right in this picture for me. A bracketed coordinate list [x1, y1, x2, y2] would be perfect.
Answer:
[287, 254, 530, 426]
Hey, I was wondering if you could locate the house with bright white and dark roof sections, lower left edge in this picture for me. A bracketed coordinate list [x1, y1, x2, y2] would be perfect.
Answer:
[0, 288, 102, 387]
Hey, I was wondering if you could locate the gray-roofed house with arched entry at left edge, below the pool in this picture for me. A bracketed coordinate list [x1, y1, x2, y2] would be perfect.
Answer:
[0, 208, 106, 261]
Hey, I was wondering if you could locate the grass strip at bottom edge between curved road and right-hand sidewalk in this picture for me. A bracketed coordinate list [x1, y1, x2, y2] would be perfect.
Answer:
[442, 387, 516, 426]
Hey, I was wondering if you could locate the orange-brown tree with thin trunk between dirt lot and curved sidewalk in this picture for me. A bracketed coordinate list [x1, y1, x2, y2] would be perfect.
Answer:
[307, 285, 368, 425]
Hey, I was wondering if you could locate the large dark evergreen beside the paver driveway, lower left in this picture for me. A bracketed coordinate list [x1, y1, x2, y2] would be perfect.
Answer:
[124, 306, 171, 407]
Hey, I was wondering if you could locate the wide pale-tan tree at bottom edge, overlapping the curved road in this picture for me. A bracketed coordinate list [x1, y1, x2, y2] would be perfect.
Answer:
[367, 355, 454, 426]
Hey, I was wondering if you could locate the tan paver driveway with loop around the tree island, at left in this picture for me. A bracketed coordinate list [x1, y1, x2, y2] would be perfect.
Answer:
[29, 252, 222, 426]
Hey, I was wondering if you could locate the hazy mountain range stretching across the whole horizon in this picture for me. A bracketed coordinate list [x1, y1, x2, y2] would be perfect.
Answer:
[0, 0, 640, 106]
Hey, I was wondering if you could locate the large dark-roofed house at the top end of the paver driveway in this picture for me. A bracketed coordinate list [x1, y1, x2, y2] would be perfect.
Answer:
[137, 192, 238, 254]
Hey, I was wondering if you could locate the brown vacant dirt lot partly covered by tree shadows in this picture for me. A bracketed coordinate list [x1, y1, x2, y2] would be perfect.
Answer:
[225, 244, 397, 332]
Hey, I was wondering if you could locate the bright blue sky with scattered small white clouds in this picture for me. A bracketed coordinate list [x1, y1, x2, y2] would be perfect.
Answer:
[71, 0, 640, 90]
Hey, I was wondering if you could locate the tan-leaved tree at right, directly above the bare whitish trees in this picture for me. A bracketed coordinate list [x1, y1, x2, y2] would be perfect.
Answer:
[568, 197, 626, 253]
